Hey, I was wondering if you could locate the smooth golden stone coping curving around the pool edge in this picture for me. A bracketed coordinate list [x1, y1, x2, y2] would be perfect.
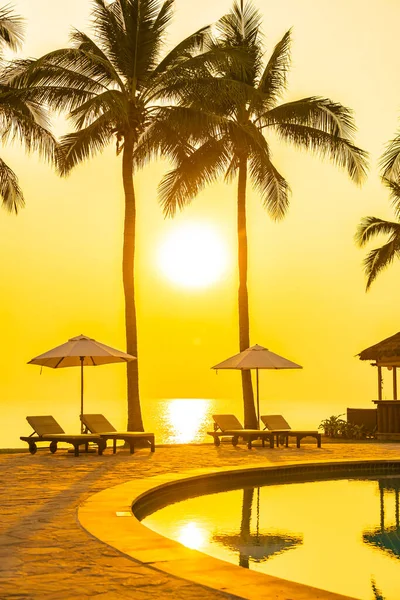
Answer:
[77, 459, 400, 600]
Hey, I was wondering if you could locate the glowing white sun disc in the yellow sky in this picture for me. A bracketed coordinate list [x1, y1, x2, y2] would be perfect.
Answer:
[158, 223, 228, 288]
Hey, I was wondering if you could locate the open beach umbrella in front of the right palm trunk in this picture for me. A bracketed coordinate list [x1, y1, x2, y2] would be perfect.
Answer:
[211, 344, 303, 427]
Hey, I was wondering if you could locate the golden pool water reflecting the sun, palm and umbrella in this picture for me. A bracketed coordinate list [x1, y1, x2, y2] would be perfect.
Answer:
[143, 475, 400, 600]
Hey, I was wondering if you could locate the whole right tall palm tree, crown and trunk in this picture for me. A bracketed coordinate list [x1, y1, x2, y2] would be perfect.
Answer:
[159, 2, 366, 427]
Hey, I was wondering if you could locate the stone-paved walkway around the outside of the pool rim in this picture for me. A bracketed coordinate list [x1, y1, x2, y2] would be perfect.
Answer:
[0, 443, 400, 600]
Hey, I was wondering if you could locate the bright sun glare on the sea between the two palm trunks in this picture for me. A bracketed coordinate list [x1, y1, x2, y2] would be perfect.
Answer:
[164, 398, 210, 444]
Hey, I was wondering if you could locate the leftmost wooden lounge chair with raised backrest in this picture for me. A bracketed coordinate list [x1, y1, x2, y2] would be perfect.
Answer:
[20, 415, 106, 456]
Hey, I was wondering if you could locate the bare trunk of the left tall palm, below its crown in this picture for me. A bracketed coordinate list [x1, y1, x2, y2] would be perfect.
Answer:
[122, 135, 144, 431]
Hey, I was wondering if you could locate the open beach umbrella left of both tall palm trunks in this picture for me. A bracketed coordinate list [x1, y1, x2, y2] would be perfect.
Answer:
[28, 334, 136, 433]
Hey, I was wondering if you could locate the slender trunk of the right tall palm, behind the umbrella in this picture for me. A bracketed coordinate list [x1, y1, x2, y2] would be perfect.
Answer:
[237, 157, 258, 429]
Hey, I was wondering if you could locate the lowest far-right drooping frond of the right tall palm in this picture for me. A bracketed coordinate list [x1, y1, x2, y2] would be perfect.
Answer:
[276, 123, 367, 184]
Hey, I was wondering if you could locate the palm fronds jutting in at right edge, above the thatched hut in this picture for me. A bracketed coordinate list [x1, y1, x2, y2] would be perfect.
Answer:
[355, 177, 400, 291]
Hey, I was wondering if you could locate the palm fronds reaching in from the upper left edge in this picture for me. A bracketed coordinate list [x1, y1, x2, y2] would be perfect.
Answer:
[0, 6, 55, 214]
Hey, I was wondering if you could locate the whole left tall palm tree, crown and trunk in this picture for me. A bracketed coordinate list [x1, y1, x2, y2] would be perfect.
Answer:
[10, 0, 233, 431]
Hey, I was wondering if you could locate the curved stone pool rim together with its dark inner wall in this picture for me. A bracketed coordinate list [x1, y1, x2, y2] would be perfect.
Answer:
[78, 460, 400, 600]
